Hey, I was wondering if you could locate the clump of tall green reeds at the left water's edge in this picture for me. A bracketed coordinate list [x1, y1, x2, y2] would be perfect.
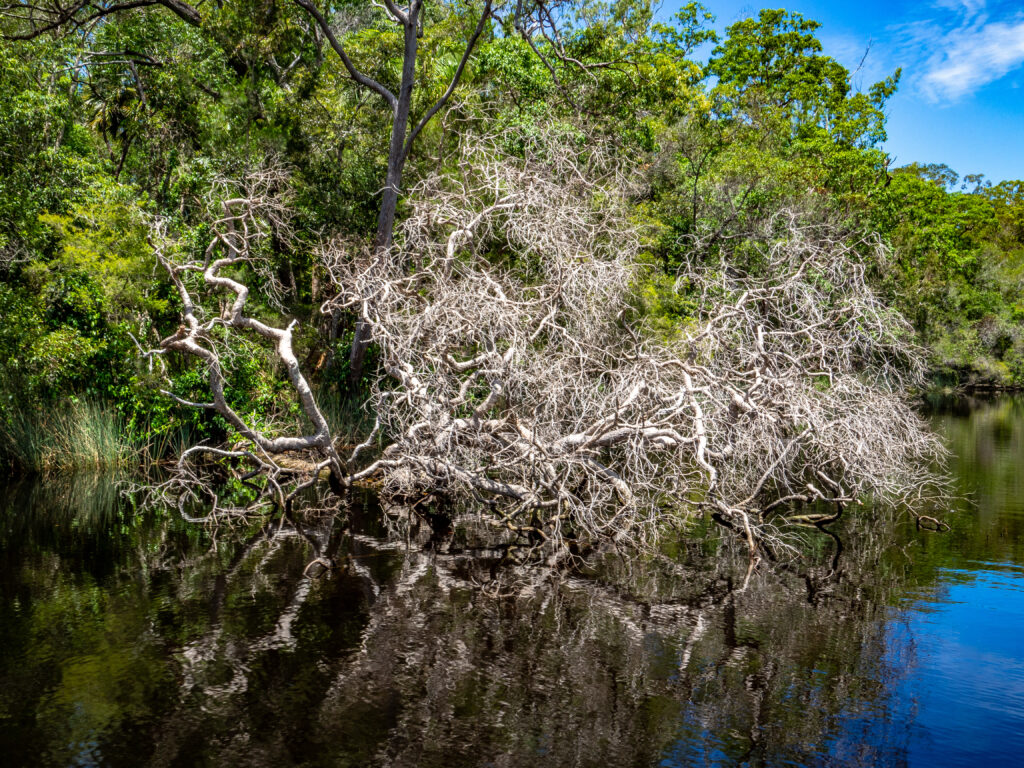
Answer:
[0, 400, 146, 472]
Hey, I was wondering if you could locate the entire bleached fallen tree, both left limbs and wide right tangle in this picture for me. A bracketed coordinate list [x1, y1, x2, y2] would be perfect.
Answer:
[144, 140, 941, 556]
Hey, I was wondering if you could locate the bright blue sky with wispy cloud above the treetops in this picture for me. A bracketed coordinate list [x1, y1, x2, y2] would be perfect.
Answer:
[662, 0, 1024, 182]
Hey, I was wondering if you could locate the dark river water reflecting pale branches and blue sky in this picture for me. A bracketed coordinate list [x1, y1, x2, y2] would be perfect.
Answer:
[0, 398, 1024, 767]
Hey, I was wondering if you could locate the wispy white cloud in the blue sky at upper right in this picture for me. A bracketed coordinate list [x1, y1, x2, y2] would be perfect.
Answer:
[921, 15, 1024, 101]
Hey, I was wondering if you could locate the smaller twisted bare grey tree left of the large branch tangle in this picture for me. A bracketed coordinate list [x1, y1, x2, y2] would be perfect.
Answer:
[147, 169, 342, 516]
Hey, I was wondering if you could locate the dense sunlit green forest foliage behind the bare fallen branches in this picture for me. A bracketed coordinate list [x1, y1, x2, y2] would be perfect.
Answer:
[0, 0, 1024, 475]
